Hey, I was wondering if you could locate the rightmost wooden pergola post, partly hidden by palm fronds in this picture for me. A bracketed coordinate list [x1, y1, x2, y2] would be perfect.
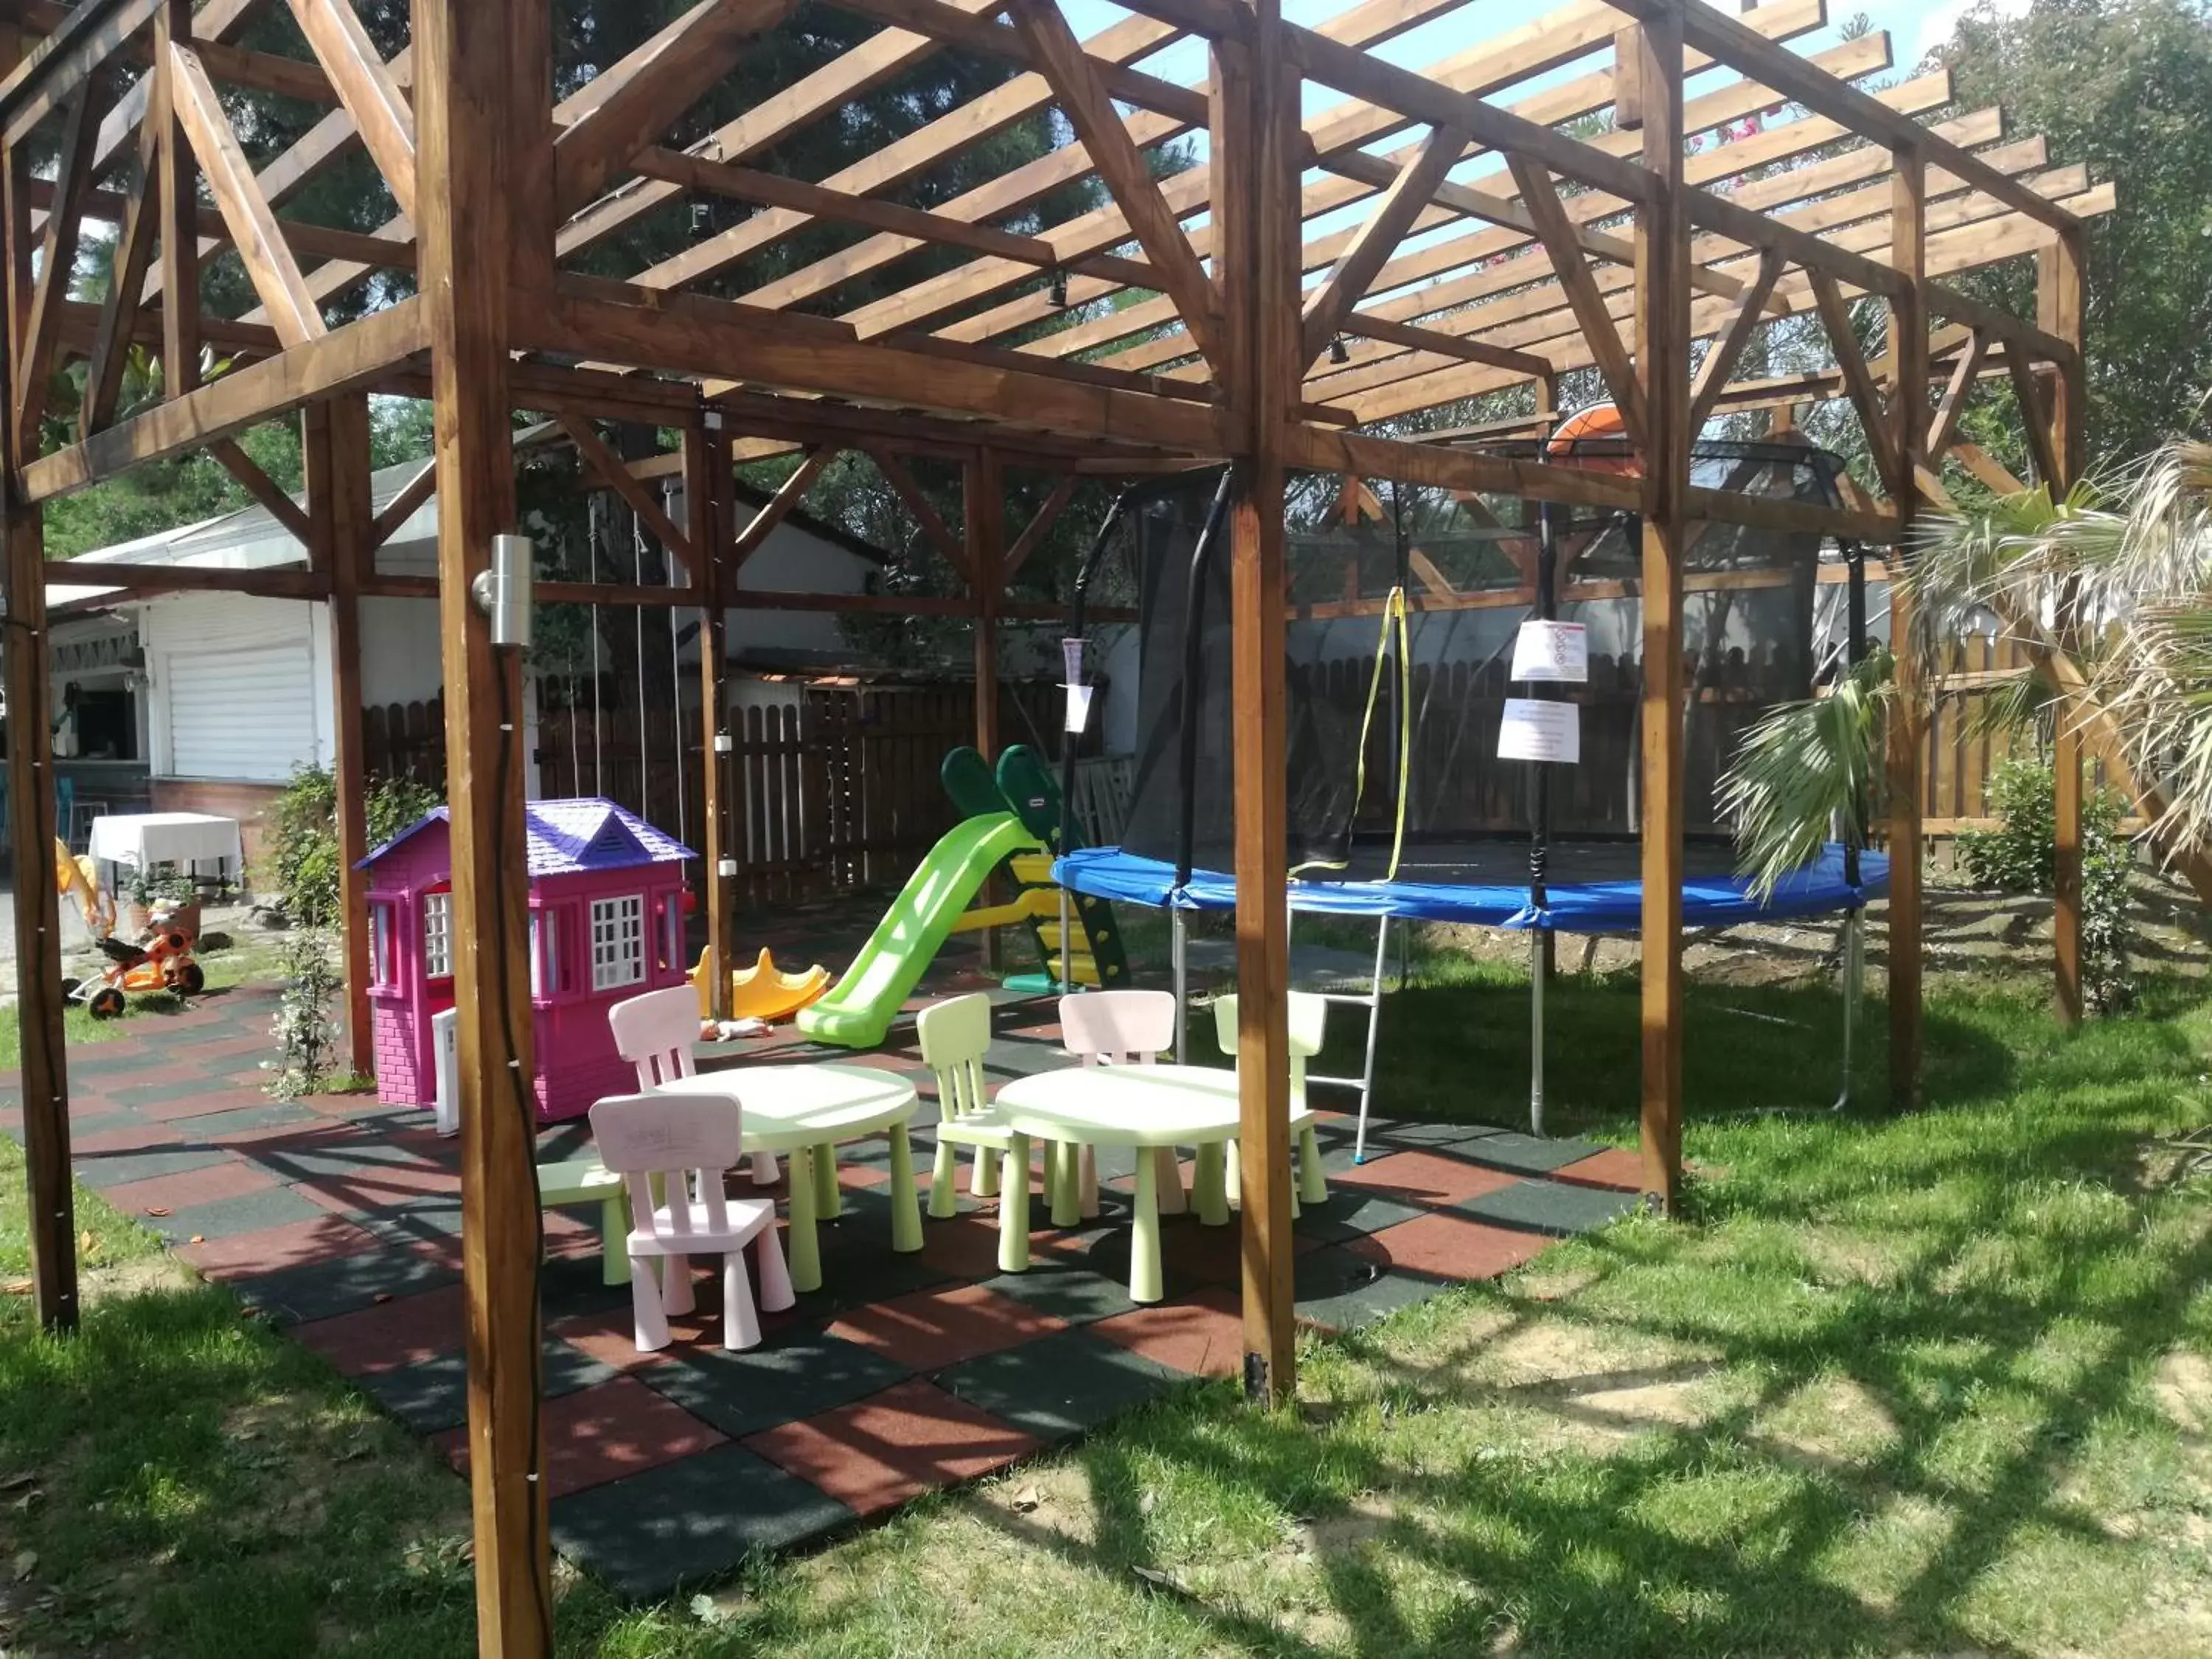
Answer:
[2020, 228, 2088, 1024]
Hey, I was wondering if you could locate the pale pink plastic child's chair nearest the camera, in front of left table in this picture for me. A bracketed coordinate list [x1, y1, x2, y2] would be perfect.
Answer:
[591, 1093, 794, 1354]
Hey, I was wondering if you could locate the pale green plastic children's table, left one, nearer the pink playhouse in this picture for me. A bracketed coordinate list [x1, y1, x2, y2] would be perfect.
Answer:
[648, 1064, 922, 1290]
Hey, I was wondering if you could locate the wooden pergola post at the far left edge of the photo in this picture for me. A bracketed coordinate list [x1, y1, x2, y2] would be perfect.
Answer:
[0, 24, 77, 1332]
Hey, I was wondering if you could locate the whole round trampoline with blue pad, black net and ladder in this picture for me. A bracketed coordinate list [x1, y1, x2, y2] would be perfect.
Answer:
[1055, 436, 1889, 1155]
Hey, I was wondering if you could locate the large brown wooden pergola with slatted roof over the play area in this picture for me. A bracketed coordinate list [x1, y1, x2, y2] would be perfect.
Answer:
[0, 0, 2112, 1652]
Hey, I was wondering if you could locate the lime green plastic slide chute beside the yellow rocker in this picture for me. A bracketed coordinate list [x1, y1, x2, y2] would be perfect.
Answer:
[799, 812, 1040, 1048]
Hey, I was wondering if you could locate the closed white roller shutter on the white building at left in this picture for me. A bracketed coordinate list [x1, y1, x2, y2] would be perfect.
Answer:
[157, 595, 319, 783]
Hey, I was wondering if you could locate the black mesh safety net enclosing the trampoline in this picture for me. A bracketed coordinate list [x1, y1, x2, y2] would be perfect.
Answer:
[1124, 440, 1845, 878]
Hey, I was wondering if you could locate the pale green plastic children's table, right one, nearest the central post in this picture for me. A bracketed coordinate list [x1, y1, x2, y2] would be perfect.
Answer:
[993, 1066, 1314, 1303]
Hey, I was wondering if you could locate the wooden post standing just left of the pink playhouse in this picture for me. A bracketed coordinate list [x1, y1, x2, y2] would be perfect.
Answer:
[301, 394, 376, 1077]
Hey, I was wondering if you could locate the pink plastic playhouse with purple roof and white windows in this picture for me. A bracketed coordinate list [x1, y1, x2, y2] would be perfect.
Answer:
[361, 799, 697, 1124]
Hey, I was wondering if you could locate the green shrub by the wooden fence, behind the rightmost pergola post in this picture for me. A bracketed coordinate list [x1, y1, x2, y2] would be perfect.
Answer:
[1958, 759, 2135, 1013]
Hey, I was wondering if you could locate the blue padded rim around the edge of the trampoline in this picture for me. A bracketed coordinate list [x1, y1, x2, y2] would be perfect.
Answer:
[1053, 841, 1889, 933]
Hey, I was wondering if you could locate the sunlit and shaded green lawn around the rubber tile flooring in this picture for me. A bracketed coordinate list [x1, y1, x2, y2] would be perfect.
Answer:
[0, 962, 2212, 1659]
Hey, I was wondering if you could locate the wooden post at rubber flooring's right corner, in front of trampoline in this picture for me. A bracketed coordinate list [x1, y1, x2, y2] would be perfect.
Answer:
[1637, 9, 1690, 1212]
